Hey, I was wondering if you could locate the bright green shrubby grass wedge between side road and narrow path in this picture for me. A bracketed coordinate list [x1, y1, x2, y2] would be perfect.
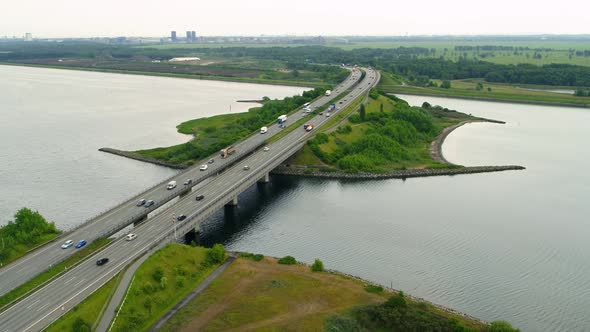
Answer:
[113, 244, 218, 331]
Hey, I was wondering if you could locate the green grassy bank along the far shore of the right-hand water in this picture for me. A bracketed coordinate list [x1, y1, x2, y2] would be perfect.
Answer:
[379, 78, 590, 107]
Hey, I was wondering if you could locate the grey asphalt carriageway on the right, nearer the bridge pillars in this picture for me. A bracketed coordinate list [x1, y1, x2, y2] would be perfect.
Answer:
[0, 66, 379, 332]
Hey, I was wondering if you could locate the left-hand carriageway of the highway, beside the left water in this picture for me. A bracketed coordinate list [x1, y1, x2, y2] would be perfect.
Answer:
[0, 68, 360, 296]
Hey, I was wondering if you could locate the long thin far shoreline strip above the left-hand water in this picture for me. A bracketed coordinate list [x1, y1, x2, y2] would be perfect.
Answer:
[0, 61, 326, 88]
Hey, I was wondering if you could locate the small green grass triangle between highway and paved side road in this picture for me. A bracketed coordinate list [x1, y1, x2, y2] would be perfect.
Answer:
[45, 274, 121, 332]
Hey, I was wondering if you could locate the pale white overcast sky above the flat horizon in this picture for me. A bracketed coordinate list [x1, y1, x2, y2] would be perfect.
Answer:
[0, 0, 590, 37]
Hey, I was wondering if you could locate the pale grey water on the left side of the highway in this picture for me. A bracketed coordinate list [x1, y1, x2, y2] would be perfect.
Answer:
[0, 66, 305, 229]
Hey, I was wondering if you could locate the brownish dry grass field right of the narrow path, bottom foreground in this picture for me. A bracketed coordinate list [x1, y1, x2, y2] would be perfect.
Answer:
[162, 257, 504, 331]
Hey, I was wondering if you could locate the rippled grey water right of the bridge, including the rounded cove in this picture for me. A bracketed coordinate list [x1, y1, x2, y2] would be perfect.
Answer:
[203, 96, 590, 331]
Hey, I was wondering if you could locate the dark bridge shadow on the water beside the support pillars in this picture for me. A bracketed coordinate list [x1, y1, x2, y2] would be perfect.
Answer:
[198, 175, 301, 247]
